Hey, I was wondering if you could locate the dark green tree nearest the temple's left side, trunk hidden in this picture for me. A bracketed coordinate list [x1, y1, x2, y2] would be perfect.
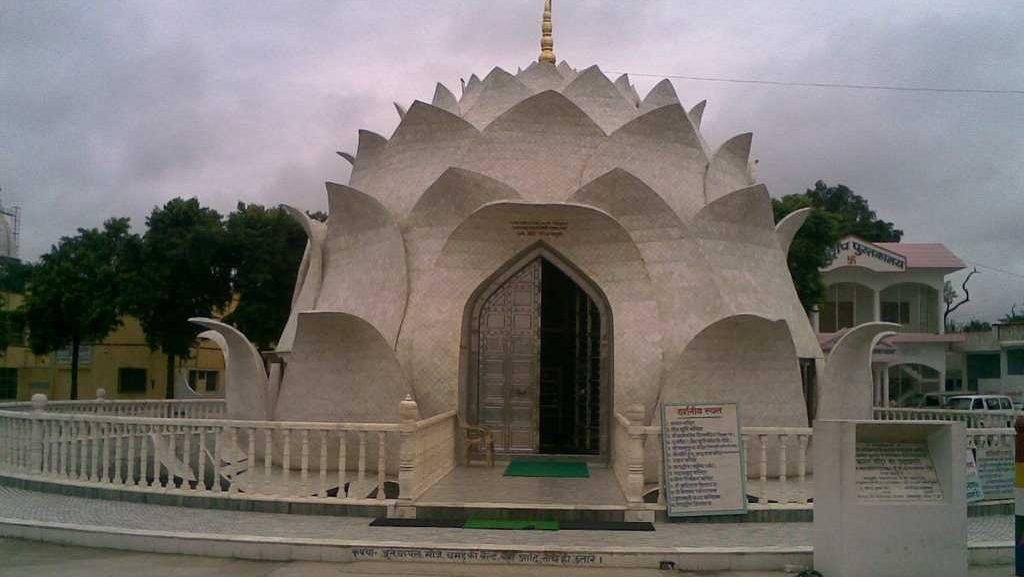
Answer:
[224, 203, 306, 348]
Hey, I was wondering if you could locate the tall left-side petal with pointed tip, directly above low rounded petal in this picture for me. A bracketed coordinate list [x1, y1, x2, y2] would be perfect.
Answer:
[319, 184, 407, 346]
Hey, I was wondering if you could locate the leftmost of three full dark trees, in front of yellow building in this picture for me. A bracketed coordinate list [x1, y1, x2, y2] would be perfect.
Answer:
[22, 218, 138, 399]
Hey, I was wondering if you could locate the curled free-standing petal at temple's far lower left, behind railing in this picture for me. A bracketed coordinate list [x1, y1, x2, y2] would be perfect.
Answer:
[188, 318, 271, 420]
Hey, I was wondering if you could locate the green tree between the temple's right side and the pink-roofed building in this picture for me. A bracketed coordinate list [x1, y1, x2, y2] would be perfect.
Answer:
[772, 180, 903, 307]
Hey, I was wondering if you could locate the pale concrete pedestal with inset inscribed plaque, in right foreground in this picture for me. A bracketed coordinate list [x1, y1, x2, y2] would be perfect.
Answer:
[813, 420, 968, 577]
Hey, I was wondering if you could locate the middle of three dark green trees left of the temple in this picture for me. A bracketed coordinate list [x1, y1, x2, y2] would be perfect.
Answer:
[125, 198, 231, 399]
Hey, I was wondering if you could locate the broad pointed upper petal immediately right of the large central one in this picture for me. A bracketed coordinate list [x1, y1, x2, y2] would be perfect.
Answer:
[583, 102, 708, 218]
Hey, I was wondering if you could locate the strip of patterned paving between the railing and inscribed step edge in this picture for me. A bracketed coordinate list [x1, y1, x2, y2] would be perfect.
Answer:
[0, 486, 1013, 549]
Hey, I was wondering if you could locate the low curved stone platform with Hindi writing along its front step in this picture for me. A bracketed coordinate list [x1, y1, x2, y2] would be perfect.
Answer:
[0, 487, 1013, 570]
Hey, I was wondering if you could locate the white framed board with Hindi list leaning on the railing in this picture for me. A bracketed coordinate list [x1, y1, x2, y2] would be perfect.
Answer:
[662, 403, 746, 517]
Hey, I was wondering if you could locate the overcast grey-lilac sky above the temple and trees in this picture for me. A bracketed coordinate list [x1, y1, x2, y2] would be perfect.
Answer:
[0, 0, 1024, 319]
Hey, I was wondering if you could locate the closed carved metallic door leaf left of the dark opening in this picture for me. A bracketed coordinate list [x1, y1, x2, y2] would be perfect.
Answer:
[477, 259, 541, 453]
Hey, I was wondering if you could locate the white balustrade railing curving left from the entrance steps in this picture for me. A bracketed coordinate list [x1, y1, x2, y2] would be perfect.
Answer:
[0, 399, 456, 502]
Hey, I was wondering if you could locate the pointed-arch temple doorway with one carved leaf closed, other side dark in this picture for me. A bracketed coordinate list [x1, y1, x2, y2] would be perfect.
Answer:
[463, 248, 611, 455]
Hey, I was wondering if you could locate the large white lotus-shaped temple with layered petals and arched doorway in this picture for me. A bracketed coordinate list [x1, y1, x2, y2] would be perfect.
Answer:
[190, 2, 888, 504]
